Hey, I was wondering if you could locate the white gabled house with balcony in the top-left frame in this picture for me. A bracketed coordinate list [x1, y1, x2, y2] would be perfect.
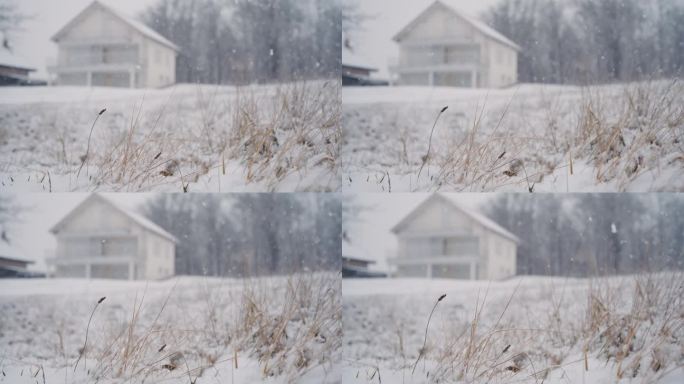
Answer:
[48, 1, 178, 88]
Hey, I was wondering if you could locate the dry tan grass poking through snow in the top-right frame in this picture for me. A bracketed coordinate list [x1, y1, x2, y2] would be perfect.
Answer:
[397, 80, 684, 192]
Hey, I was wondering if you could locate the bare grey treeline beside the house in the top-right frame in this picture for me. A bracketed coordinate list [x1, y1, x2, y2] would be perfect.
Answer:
[485, 0, 684, 84]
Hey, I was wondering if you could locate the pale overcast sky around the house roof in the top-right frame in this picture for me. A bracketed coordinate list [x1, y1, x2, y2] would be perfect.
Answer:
[343, 0, 500, 76]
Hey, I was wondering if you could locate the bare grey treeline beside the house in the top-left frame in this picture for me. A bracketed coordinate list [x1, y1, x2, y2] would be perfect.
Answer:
[142, 0, 342, 84]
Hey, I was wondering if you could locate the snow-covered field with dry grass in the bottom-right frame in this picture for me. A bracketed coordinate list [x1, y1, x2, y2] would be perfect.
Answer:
[342, 274, 684, 384]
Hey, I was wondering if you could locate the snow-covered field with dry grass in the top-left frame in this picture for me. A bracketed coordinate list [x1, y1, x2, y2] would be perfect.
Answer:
[0, 80, 340, 192]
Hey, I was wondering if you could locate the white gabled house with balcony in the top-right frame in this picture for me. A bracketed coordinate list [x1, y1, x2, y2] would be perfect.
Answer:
[391, 0, 520, 88]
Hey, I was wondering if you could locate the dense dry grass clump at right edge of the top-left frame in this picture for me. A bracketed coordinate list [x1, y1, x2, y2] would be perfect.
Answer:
[228, 82, 341, 186]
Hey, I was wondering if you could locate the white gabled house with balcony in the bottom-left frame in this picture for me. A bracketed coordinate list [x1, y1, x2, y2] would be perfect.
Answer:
[48, 194, 176, 280]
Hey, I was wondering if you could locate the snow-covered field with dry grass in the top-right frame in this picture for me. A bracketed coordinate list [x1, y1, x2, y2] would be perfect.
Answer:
[341, 81, 684, 192]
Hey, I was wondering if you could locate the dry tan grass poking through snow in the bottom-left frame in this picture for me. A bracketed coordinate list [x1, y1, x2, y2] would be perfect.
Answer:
[47, 273, 342, 382]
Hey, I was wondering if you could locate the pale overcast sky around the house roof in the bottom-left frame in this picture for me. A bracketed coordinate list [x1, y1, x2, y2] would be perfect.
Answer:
[0, 193, 154, 270]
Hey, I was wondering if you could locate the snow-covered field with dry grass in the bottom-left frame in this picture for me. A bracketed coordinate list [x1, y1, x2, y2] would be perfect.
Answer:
[0, 273, 342, 384]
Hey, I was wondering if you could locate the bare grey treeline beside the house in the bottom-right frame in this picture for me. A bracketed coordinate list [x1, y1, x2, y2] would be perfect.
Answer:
[486, 193, 684, 276]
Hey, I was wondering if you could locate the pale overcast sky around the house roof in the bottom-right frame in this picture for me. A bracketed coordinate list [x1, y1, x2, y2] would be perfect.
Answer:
[345, 193, 496, 271]
